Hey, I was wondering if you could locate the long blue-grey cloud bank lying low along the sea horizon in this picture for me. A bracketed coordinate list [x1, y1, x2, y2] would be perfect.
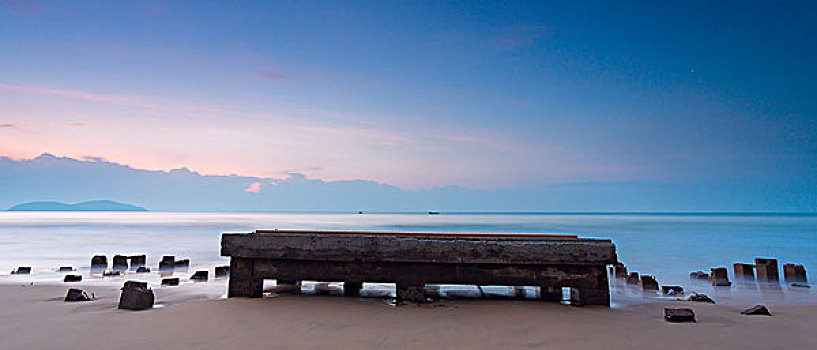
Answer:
[0, 154, 817, 212]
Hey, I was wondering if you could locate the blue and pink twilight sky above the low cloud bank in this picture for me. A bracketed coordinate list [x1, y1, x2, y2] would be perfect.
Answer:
[0, 0, 817, 201]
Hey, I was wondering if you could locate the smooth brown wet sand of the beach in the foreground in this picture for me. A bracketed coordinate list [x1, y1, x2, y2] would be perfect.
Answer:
[0, 285, 817, 349]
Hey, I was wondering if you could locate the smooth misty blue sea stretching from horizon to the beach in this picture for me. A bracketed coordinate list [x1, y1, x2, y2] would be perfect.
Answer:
[0, 212, 817, 298]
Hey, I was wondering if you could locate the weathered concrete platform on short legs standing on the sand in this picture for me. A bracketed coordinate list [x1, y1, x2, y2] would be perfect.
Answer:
[221, 230, 617, 306]
